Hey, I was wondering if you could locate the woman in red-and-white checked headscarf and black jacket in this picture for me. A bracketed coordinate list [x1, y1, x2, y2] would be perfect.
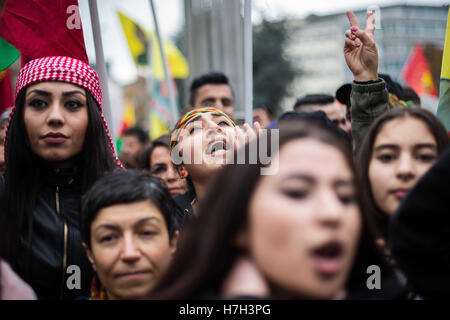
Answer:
[0, 56, 121, 299]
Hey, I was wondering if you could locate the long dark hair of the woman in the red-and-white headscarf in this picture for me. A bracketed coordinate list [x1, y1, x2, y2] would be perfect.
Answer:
[0, 90, 116, 264]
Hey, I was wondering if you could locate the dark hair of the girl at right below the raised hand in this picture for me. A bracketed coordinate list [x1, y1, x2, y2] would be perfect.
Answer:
[356, 107, 449, 240]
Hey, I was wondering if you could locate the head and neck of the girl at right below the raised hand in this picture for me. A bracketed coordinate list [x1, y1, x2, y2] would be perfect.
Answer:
[356, 107, 449, 249]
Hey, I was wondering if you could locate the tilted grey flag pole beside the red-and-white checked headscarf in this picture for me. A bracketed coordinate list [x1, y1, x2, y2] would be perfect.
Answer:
[89, 0, 116, 142]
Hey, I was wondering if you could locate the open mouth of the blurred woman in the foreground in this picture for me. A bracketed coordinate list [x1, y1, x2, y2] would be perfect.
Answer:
[312, 241, 344, 278]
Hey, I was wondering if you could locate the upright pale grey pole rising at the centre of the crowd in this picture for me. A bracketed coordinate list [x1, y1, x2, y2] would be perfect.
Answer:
[244, 0, 253, 125]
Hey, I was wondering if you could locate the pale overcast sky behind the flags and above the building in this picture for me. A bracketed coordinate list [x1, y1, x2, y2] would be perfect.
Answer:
[79, 0, 449, 84]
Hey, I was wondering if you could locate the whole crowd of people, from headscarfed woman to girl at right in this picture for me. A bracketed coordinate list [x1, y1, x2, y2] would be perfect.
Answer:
[0, 11, 450, 300]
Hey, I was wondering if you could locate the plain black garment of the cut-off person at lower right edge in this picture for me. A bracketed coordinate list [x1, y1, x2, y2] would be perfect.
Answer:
[390, 147, 450, 299]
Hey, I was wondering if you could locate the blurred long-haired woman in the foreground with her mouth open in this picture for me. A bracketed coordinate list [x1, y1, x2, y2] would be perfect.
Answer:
[149, 120, 394, 299]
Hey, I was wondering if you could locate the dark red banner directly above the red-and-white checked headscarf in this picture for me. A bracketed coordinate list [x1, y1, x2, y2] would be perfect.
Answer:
[0, 0, 88, 65]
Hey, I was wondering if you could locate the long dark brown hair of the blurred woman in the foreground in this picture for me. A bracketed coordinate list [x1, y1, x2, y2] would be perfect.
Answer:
[153, 119, 382, 299]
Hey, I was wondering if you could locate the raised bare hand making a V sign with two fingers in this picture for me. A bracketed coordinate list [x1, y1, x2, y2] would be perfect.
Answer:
[344, 11, 378, 82]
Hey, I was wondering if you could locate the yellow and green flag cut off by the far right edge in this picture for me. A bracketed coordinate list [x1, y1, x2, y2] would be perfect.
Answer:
[437, 11, 450, 133]
